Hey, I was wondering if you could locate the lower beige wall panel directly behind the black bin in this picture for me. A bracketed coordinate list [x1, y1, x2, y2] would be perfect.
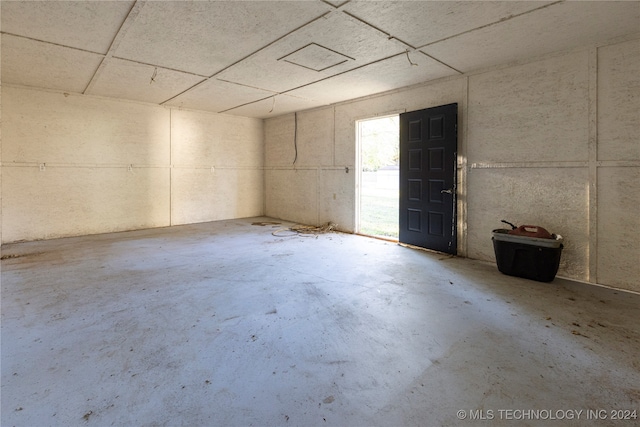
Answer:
[468, 168, 589, 280]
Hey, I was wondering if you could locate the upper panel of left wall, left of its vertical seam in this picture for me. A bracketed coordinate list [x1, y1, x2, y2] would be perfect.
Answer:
[2, 87, 169, 165]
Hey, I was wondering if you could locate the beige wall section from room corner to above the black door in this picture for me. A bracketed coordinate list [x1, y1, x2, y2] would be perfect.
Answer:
[265, 79, 466, 237]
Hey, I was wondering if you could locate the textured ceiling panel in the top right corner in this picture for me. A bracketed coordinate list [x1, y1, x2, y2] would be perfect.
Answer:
[421, 2, 640, 72]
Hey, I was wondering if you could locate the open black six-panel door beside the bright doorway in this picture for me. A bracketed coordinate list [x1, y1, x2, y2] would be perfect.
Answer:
[399, 104, 458, 255]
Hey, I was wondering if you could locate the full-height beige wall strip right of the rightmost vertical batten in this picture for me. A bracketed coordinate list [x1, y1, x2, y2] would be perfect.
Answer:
[592, 40, 640, 292]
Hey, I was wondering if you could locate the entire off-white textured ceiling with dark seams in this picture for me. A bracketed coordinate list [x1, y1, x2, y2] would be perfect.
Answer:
[0, 0, 640, 118]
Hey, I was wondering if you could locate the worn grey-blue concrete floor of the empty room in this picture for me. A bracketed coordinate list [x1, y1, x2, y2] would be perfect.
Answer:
[1, 218, 640, 426]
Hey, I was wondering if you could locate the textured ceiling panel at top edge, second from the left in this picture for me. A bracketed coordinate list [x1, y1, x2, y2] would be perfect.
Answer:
[115, 1, 331, 76]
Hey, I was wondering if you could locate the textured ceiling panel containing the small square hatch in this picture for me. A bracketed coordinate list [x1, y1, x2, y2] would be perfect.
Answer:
[217, 12, 404, 92]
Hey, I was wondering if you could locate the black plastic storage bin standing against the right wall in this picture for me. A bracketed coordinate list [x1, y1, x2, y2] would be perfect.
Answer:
[491, 229, 563, 282]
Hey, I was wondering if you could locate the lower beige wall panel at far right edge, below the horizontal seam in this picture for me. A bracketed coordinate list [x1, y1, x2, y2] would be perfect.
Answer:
[597, 167, 640, 292]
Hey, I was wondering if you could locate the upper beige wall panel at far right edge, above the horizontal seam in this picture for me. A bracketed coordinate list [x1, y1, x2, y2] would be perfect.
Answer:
[598, 40, 640, 160]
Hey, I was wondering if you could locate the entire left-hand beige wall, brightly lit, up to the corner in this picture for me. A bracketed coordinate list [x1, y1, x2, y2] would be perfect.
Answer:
[2, 86, 264, 242]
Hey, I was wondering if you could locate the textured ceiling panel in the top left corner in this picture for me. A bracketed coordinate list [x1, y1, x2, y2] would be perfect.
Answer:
[1, 1, 135, 53]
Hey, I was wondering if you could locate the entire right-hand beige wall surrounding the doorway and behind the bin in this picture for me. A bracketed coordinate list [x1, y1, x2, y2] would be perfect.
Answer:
[265, 40, 640, 291]
